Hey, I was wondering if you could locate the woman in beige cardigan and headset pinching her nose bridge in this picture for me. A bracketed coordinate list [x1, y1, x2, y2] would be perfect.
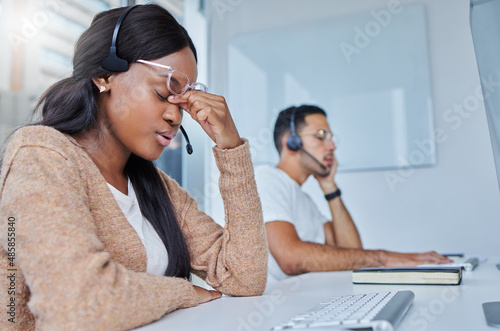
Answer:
[0, 5, 267, 330]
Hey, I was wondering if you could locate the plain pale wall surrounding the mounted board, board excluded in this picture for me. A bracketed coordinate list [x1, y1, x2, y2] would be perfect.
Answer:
[205, 0, 500, 255]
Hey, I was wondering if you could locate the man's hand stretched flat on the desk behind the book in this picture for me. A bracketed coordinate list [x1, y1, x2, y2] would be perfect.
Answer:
[381, 251, 453, 267]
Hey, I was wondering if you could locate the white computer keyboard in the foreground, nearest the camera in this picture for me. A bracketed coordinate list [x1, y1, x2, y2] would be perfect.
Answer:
[272, 291, 415, 331]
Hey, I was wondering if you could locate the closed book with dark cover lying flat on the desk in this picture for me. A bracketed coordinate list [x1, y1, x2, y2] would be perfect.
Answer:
[352, 267, 462, 285]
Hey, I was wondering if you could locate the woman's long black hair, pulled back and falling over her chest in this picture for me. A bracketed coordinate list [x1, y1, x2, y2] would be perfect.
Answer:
[35, 4, 196, 278]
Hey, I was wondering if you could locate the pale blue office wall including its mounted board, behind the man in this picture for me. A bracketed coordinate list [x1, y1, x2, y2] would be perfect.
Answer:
[205, 0, 500, 255]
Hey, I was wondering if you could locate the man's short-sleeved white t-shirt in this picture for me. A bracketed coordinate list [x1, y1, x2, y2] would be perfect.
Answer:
[255, 165, 330, 284]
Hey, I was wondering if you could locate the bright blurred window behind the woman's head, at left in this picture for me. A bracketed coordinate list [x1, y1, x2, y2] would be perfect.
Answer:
[0, 0, 199, 192]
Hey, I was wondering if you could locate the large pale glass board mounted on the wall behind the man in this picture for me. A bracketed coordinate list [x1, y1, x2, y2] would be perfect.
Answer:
[227, 5, 436, 171]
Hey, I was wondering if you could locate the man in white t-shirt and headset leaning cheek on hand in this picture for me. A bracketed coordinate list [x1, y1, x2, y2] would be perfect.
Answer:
[255, 105, 451, 283]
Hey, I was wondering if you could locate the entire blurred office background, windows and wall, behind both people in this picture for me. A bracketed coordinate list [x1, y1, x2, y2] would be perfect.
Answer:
[0, 0, 500, 255]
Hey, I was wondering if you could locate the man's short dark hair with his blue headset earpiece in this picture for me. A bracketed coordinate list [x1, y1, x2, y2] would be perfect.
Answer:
[274, 105, 326, 154]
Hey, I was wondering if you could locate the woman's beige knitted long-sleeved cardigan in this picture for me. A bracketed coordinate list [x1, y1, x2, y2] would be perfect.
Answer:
[0, 126, 268, 331]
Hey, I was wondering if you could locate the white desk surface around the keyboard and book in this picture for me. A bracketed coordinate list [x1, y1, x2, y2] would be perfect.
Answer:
[136, 257, 500, 331]
